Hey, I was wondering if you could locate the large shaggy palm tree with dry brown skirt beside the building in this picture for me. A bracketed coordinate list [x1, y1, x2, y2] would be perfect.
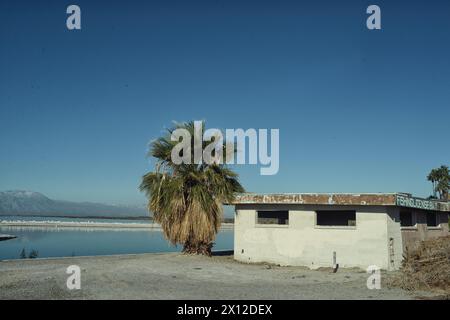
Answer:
[140, 122, 244, 255]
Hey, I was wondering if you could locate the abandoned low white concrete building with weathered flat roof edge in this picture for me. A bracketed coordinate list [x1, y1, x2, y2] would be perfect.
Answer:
[233, 193, 450, 270]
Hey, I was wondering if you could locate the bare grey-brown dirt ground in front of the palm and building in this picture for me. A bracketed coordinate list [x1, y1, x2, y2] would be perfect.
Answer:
[0, 253, 438, 299]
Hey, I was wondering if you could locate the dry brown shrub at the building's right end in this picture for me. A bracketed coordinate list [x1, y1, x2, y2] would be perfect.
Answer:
[392, 236, 450, 293]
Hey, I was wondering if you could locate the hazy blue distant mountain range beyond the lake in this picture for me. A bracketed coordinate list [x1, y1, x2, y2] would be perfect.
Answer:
[0, 190, 149, 218]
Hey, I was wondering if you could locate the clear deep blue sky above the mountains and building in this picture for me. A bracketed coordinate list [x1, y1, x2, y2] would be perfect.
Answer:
[0, 0, 450, 204]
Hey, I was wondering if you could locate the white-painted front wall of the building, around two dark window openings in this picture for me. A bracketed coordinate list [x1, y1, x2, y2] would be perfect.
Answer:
[234, 205, 402, 270]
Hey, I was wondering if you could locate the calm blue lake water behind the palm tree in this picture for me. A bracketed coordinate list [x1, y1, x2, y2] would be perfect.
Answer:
[0, 217, 233, 260]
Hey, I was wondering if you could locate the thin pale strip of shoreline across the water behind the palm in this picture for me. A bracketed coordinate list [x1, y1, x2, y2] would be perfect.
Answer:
[0, 221, 234, 230]
